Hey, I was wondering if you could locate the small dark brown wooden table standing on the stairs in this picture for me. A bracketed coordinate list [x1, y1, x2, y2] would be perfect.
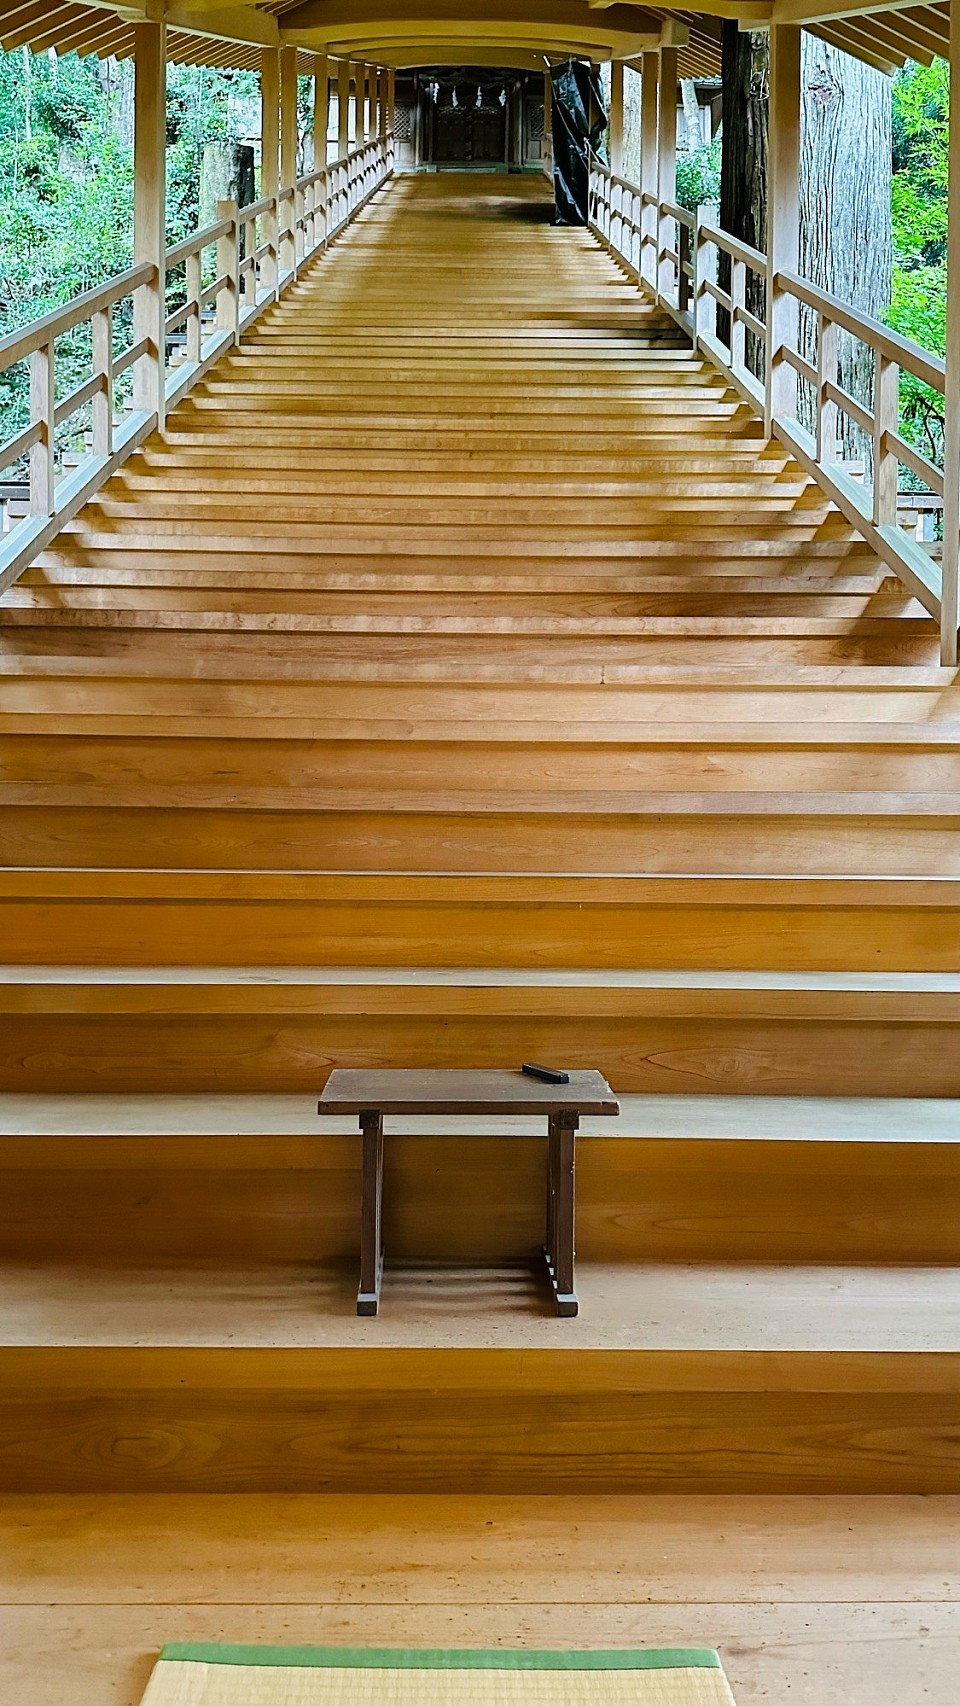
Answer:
[317, 1068, 619, 1315]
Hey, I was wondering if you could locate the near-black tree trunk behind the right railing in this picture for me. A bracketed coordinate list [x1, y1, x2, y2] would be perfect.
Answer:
[716, 20, 771, 363]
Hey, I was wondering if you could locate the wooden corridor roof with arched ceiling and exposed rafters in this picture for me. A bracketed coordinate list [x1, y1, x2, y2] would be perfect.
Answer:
[0, 0, 950, 77]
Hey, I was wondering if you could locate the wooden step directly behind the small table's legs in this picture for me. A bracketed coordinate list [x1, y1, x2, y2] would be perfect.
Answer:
[0, 1094, 960, 1269]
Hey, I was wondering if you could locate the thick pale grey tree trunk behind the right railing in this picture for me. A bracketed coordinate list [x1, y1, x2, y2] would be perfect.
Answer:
[800, 31, 893, 466]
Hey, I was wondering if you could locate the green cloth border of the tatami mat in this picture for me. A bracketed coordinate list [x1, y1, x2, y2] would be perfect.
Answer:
[160, 1641, 721, 1670]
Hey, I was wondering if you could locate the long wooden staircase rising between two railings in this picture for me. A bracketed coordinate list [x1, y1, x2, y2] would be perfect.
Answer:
[0, 174, 960, 1493]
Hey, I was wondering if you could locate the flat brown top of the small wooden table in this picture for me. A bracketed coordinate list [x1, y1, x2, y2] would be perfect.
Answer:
[317, 1066, 621, 1114]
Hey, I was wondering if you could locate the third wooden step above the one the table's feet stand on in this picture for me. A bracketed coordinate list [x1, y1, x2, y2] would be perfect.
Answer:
[0, 870, 960, 972]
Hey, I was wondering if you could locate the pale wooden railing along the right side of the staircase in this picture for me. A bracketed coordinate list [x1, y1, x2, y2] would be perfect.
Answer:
[588, 159, 957, 662]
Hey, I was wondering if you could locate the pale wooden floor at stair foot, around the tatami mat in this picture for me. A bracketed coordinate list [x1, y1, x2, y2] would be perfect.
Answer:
[0, 1494, 960, 1706]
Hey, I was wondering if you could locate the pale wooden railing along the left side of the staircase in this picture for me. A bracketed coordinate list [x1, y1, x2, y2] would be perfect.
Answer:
[0, 131, 394, 592]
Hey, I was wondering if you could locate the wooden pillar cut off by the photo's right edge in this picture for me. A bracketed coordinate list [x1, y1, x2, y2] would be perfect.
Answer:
[940, 3, 960, 665]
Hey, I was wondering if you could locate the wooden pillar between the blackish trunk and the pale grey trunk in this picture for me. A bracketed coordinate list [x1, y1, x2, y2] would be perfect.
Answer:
[764, 24, 800, 435]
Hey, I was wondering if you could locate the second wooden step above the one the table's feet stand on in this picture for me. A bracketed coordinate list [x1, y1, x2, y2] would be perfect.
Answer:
[0, 966, 960, 1097]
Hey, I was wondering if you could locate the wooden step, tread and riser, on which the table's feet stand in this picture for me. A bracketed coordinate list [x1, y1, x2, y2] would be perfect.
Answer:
[0, 1262, 960, 1493]
